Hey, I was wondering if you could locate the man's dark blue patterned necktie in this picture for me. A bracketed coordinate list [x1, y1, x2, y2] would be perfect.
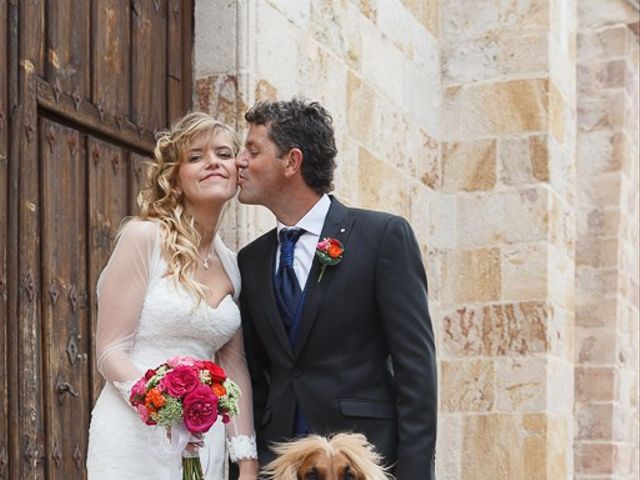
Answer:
[275, 228, 305, 340]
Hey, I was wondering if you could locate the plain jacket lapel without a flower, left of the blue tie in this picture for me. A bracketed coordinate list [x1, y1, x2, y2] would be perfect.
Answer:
[257, 229, 292, 356]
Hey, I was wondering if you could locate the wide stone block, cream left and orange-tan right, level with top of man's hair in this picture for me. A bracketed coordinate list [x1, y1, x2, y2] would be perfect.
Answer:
[442, 79, 549, 139]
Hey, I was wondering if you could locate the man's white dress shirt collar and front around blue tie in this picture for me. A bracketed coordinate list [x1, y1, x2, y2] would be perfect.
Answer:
[276, 194, 331, 290]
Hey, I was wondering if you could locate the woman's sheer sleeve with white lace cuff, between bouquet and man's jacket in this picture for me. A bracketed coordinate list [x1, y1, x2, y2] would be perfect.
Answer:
[217, 329, 258, 462]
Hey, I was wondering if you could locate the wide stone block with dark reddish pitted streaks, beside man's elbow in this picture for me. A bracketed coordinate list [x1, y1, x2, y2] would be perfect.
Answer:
[440, 302, 553, 358]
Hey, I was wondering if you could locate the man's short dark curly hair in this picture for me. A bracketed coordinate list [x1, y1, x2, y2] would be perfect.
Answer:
[244, 98, 338, 194]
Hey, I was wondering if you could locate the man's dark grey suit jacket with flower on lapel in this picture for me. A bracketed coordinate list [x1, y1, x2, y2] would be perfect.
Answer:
[238, 198, 437, 480]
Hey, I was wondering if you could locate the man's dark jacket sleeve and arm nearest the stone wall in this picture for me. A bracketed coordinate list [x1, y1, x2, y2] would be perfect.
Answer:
[376, 217, 437, 480]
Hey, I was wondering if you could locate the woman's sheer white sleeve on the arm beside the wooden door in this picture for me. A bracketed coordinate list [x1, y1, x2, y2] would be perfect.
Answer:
[96, 220, 158, 402]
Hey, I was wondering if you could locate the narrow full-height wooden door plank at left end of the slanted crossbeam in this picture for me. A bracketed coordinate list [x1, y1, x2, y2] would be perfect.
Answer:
[12, 0, 47, 479]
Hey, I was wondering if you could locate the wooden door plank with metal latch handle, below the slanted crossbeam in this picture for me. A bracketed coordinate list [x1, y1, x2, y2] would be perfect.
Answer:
[40, 119, 91, 479]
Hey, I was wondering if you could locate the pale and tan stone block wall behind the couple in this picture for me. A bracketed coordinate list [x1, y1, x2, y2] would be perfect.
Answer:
[195, 0, 638, 480]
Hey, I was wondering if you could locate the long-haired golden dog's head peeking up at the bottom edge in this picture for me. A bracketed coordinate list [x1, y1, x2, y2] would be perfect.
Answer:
[261, 433, 393, 480]
